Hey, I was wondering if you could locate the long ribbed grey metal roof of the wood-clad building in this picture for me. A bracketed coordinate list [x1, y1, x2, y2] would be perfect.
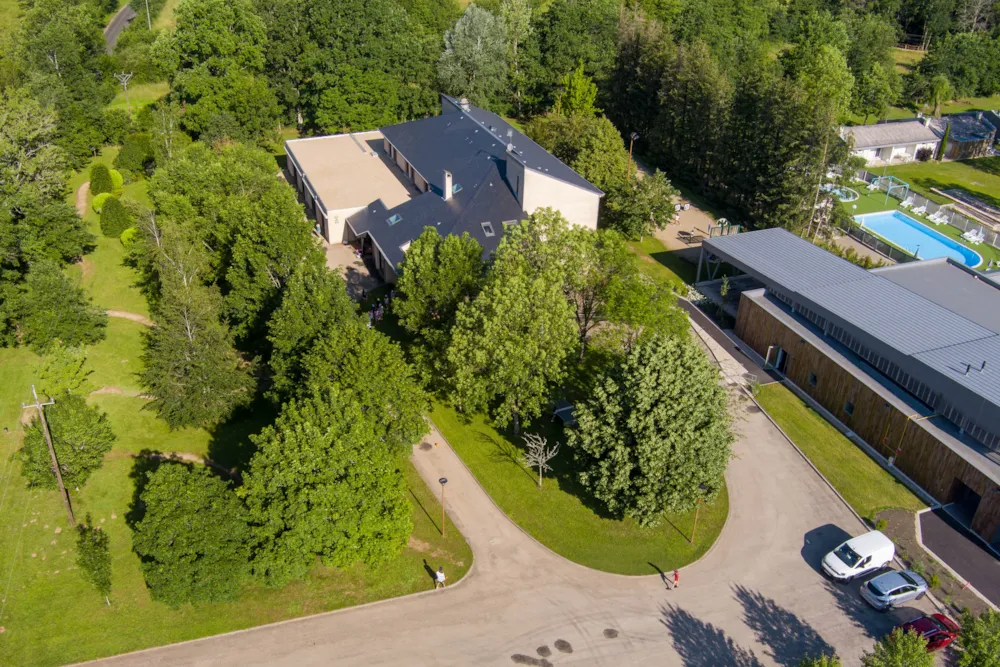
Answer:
[702, 229, 1000, 433]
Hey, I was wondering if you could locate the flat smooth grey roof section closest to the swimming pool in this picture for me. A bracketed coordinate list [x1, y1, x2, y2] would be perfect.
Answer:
[872, 257, 1000, 333]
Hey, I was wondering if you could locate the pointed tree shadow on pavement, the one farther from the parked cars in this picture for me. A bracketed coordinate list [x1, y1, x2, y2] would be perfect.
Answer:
[660, 605, 763, 667]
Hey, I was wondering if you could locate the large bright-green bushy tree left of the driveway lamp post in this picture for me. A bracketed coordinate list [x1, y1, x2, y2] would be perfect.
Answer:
[240, 388, 413, 585]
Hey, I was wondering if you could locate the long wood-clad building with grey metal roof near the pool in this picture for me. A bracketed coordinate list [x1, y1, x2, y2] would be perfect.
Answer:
[702, 229, 1000, 544]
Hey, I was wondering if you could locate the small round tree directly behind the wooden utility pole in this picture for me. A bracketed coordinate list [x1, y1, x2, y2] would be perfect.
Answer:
[20, 394, 115, 489]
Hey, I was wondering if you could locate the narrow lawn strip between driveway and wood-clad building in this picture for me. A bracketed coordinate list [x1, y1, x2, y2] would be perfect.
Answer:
[757, 383, 924, 518]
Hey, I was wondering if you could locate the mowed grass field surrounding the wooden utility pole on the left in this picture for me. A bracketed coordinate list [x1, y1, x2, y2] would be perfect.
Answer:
[0, 150, 472, 665]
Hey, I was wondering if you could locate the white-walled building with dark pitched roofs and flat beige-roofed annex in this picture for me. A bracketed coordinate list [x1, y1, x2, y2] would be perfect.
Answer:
[285, 95, 604, 282]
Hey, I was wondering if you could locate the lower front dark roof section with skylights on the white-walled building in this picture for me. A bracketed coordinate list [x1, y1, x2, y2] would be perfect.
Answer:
[347, 163, 526, 267]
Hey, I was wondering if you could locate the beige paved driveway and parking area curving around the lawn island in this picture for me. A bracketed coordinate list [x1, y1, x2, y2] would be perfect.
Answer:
[90, 392, 932, 667]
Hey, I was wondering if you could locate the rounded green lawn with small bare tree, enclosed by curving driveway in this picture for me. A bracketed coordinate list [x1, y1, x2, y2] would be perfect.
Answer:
[431, 404, 729, 575]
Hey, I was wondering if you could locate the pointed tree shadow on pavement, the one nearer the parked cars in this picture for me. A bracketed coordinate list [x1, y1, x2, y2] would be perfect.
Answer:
[733, 585, 836, 667]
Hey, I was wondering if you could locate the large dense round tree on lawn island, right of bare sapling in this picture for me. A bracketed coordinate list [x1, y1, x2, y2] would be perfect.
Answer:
[567, 335, 733, 525]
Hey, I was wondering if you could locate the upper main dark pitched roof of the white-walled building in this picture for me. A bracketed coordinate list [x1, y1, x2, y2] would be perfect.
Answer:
[381, 95, 603, 194]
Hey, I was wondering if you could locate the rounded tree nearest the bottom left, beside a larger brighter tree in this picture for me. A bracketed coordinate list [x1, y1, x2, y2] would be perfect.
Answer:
[132, 462, 250, 607]
